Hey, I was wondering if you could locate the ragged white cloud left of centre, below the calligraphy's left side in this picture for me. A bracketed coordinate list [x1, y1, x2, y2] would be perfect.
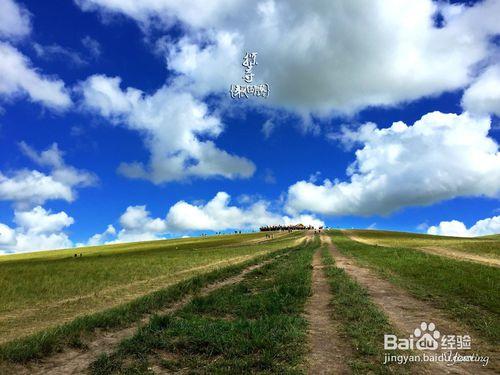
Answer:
[81, 75, 255, 184]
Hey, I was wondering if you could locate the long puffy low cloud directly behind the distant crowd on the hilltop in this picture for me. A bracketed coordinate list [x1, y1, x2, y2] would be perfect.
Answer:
[89, 192, 324, 244]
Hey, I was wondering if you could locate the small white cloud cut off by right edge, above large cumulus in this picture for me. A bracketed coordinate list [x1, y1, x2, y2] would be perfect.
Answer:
[462, 64, 500, 116]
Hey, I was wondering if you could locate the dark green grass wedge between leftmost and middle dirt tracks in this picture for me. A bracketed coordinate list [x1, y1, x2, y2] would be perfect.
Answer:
[92, 239, 319, 374]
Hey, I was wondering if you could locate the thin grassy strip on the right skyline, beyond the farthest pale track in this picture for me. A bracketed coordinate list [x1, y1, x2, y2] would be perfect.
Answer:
[345, 229, 500, 259]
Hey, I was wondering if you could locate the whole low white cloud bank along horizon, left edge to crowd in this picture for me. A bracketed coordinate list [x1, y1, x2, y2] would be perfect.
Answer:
[0, 191, 324, 254]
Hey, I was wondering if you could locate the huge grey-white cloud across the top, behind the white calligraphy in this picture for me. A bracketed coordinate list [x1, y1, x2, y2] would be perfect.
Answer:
[77, 0, 500, 114]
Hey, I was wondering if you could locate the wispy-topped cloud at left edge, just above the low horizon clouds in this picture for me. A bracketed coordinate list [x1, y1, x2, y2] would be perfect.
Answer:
[0, 142, 97, 207]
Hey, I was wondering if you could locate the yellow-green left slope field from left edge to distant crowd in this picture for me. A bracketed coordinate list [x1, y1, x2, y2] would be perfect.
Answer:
[0, 233, 302, 342]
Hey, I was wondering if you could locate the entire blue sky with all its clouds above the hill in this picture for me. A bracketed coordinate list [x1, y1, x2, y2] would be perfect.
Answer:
[0, 0, 500, 252]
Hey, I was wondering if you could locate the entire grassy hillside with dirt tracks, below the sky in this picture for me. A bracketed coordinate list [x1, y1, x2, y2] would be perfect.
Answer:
[0, 230, 500, 375]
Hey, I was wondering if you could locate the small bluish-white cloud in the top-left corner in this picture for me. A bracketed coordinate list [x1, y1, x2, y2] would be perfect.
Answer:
[0, 0, 31, 39]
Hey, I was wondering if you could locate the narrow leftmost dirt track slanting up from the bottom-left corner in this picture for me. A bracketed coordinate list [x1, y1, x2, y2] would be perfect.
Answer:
[5, 258, 282, 375]
